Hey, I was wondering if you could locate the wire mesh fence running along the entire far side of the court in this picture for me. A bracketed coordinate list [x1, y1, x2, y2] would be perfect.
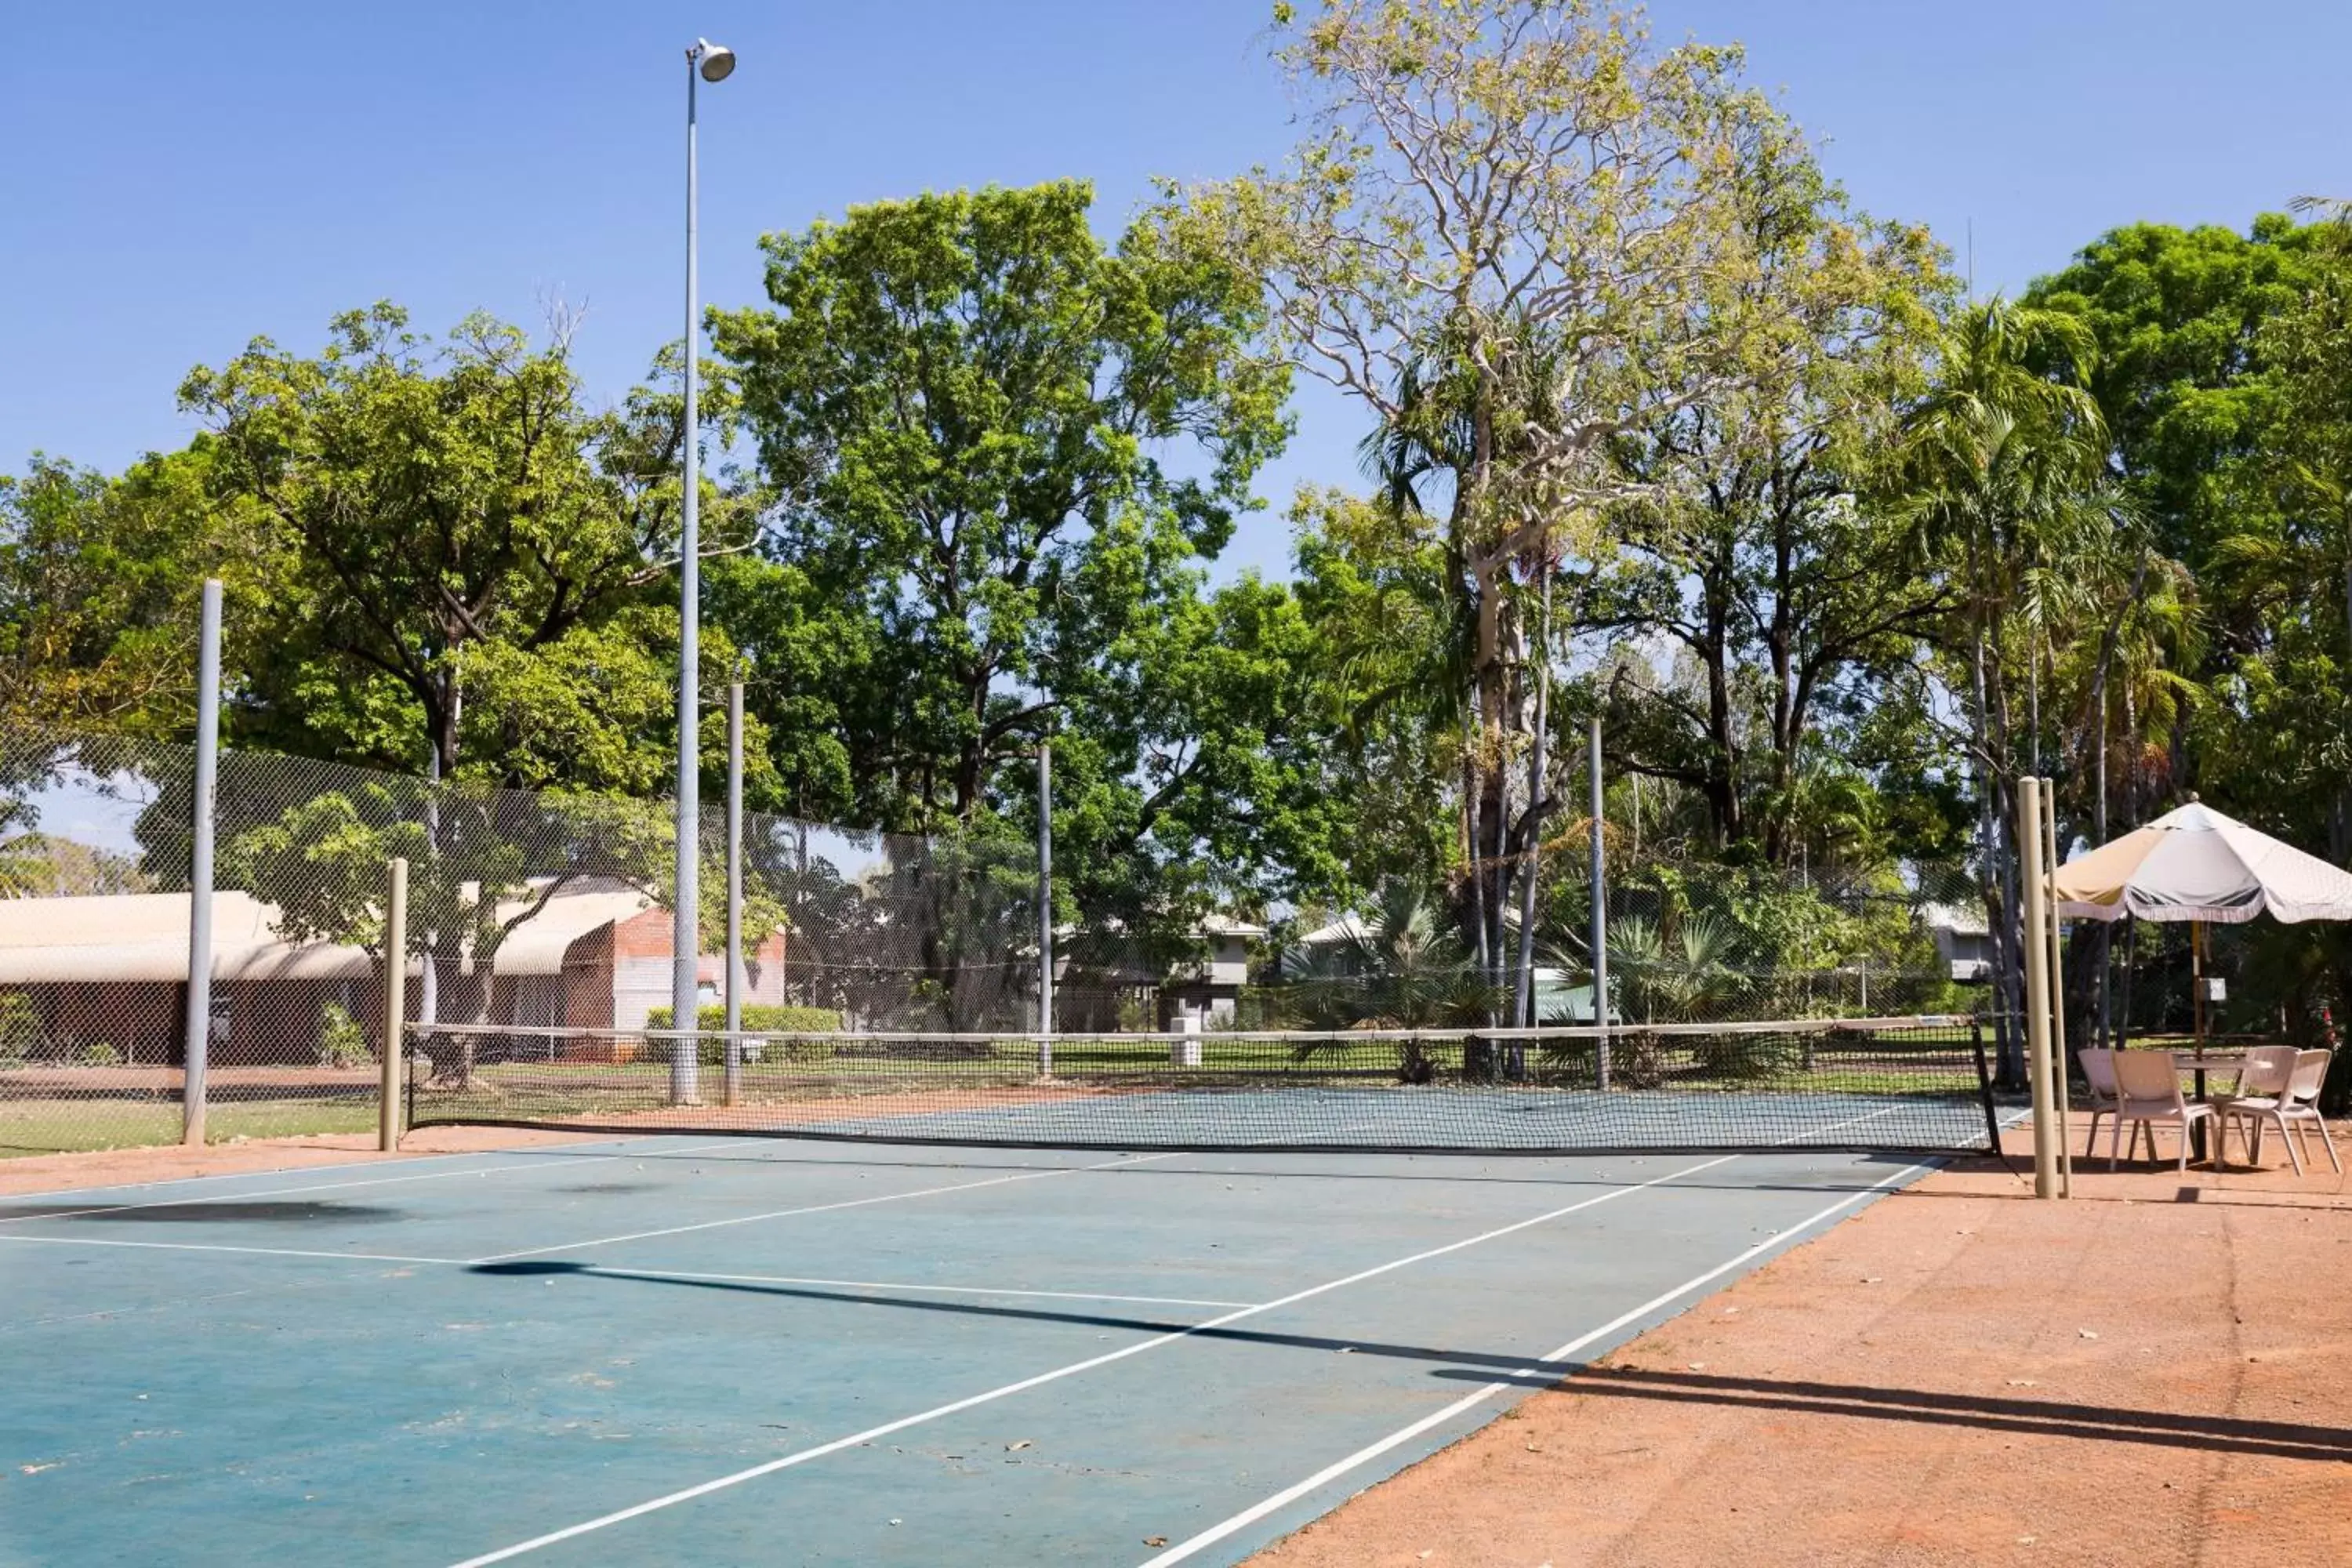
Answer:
[0, 731, 2023, 1152]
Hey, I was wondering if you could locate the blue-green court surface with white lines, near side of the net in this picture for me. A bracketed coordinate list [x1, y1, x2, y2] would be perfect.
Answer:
[0, 1138, 1924, 1568]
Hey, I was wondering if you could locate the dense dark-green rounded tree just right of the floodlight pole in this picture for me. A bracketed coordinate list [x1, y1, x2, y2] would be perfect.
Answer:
[715, 181, 1284, 829]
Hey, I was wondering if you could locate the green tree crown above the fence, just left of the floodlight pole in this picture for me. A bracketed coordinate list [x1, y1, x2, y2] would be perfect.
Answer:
[181, 303, 743, 792]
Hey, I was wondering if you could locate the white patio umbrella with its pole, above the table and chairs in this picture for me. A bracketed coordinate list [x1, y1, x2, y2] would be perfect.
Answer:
[2051, 799, 2352, 1053]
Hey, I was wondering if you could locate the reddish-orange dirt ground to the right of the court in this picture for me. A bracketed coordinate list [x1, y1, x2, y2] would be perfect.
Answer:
[1254, 1128, 2352, 1568]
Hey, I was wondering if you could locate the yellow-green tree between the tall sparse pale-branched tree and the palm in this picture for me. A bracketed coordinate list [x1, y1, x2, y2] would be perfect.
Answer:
[1588, 127, 1952, 865]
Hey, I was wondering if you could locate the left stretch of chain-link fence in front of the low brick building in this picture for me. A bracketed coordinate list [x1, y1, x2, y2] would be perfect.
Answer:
[0, 731, 1058, 1154]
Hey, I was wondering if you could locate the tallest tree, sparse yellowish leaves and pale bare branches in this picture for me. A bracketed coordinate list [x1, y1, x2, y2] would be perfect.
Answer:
[1157, 0, 1790, 971]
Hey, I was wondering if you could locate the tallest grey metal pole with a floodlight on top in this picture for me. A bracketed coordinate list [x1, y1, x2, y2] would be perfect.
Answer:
[670, 38, 734, 1105]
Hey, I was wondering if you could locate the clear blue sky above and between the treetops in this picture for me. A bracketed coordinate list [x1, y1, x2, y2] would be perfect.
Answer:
[0, 0, 2352, 583]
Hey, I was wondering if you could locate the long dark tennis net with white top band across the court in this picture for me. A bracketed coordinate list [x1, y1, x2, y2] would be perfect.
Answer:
[407, 1015, 2002, 1154]
